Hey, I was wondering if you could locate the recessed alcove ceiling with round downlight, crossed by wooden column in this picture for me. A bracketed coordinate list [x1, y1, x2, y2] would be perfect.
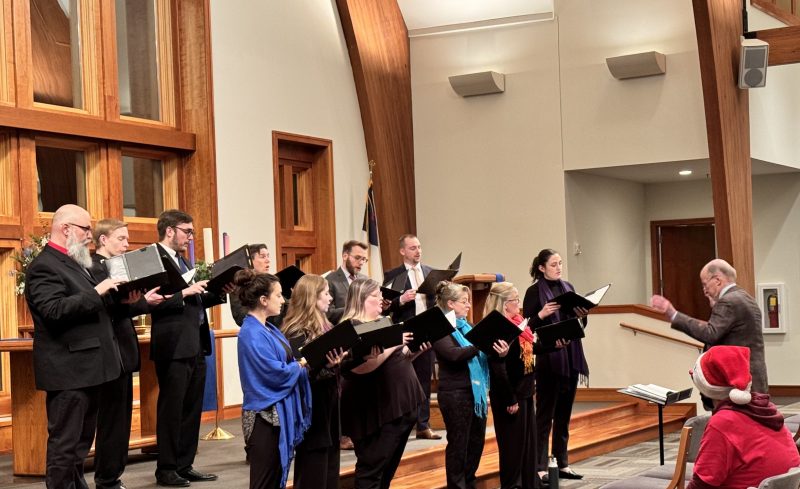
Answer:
[572, 159, 800, 183]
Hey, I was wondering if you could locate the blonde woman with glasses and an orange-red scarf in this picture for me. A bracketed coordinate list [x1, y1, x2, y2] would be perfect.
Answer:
[483, 282, 546, 489]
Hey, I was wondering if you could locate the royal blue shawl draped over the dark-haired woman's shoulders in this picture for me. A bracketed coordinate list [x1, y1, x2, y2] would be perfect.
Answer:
[238, 314, 311, 487]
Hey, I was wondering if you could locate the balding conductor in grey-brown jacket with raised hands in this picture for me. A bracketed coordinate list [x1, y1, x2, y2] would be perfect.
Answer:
[651, 259, 768, 408]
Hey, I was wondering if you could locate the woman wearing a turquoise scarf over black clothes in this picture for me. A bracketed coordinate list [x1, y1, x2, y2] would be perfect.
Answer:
[433, 282, 508, 489]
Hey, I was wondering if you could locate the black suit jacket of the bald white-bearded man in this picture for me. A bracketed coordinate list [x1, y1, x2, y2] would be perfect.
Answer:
[25, 246, 121, 391]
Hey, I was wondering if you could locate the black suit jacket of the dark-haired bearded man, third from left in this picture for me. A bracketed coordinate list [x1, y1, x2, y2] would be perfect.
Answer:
[150, 244, 225, 362]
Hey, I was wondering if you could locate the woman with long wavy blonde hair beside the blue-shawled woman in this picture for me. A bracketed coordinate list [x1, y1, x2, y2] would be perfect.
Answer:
[281, 275, 343, 489]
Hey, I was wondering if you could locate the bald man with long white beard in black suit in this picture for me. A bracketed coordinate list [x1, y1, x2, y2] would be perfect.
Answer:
[25, 204, 121, 488]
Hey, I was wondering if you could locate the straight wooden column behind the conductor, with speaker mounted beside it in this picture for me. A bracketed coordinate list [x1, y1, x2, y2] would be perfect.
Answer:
[692, 0, 755, 294]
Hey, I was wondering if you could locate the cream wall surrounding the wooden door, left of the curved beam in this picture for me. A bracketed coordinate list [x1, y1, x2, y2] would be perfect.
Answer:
[208, 0, 368, 404]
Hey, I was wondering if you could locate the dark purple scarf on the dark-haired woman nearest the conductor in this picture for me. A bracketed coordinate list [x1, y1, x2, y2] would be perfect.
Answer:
[536, 279, 589, 378]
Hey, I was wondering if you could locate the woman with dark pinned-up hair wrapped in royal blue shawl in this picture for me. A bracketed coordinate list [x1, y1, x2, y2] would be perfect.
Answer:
[235, 269, 311, 489]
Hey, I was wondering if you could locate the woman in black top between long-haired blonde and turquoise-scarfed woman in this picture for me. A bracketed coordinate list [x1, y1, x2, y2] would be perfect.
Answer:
[342, 278, 430, 489]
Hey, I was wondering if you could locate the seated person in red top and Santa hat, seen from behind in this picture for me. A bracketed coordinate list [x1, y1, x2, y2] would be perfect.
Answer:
[687, 346, 800, 489]
